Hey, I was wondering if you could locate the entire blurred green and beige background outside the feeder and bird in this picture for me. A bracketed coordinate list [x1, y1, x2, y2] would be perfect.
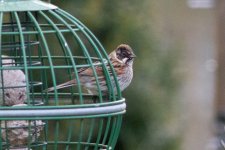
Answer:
[48, 0, 225, 150]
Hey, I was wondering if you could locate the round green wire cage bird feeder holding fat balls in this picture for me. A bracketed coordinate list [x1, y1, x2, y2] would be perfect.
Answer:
[0, 0, 126, 150]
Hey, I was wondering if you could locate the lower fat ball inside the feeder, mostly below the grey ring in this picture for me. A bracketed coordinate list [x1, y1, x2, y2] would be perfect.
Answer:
[1, 104, 45, 150]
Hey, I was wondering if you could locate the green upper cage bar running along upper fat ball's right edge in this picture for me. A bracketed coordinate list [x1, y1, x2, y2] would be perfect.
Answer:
[14, 12, 30, 104]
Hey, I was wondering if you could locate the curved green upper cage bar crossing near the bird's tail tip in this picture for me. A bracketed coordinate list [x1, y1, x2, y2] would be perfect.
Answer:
[28, 12, 58, 105]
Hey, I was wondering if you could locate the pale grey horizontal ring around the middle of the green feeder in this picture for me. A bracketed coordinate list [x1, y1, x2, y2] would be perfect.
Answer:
[0, 99, 126, 119]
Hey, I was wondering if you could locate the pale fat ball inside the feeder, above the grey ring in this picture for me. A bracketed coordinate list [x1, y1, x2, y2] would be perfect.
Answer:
[0, 55, 27, 106]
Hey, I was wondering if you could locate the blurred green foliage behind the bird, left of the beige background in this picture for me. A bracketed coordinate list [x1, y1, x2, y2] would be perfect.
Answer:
[52, 0, 180, 150]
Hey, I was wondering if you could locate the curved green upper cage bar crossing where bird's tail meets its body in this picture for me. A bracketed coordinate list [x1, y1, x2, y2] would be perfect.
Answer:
[39, 11, 83, 103]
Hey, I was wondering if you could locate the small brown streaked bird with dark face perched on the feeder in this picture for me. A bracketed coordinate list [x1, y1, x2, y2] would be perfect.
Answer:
[46, 44, 136, 95]
